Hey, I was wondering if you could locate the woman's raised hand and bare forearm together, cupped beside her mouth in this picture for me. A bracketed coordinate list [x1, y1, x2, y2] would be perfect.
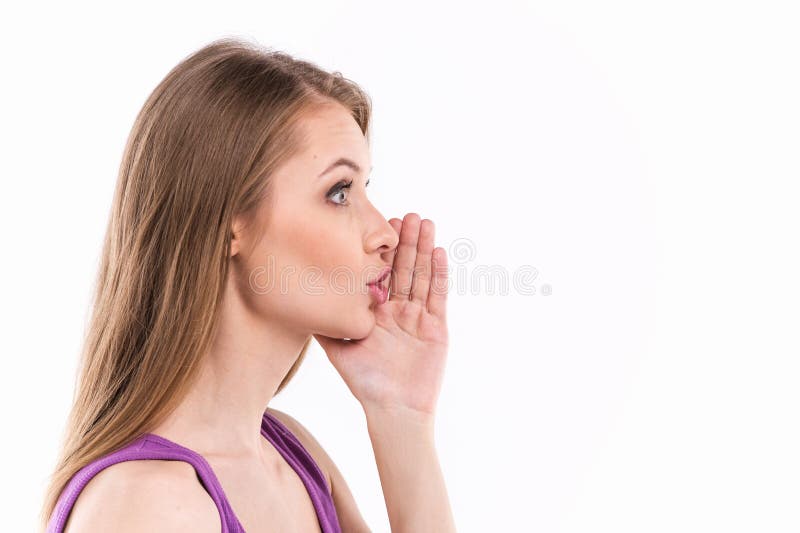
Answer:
[315, 213, 456, 533]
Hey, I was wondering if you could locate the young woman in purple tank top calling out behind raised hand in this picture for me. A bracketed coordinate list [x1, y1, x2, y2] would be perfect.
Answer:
[41, 39, 455, 533]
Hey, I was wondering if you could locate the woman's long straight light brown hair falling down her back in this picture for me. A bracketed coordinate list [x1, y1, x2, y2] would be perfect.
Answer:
[40, 37, 371, 530]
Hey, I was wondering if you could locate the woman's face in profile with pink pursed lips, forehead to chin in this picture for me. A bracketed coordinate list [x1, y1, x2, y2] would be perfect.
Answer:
[231, 105, 398, 339]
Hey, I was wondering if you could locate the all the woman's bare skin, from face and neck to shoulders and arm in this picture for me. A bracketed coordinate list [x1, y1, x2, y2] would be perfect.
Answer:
[61, 104, 455, 533]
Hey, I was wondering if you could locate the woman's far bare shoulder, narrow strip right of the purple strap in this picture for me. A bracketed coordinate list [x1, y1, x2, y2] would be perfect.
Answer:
[267, 407, 372, 533]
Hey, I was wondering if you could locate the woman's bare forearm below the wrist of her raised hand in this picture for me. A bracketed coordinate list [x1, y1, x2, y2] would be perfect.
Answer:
[365, 409, 456, 533]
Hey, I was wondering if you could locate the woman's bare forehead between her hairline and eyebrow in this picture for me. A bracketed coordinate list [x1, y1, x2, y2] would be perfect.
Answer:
[298, 104, 372, 177]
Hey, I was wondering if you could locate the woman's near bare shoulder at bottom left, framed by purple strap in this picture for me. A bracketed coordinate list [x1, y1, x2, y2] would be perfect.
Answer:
[64, 460, 221, 533]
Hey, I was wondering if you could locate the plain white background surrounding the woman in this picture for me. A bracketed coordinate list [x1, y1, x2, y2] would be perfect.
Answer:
[0, 1, 800, 533]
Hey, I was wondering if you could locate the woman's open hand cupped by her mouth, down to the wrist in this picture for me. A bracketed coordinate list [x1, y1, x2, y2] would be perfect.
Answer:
[314, 213, 448, 417]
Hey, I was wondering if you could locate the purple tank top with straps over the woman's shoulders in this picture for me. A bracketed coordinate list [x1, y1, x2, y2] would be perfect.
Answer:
[47, 411, 341, 533]
